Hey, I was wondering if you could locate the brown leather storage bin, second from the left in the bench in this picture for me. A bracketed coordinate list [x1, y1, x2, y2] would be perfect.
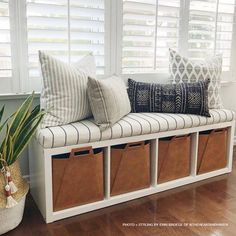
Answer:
[110, 141, 150, 196]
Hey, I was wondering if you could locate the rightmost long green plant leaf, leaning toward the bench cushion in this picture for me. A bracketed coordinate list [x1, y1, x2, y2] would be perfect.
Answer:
[12, 114, 44, 163]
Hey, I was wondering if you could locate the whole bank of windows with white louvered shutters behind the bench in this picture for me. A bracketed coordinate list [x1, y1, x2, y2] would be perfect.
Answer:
[0, 0, 236, 93]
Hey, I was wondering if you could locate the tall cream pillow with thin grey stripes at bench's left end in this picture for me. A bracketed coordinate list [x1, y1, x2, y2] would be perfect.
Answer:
[39, 51, 96, 128]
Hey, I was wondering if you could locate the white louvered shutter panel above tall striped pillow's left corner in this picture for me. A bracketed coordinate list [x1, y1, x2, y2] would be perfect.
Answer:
[27, 0, 69, 80]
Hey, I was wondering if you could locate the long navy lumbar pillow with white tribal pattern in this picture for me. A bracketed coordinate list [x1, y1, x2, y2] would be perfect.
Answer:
[128, 79, 210, 117]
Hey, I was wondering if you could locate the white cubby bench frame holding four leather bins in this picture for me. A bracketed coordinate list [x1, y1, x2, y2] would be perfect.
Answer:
[29, 121, 235, 223]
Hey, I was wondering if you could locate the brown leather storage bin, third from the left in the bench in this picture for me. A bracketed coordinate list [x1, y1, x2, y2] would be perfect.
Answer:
[157, 135, 191, 183]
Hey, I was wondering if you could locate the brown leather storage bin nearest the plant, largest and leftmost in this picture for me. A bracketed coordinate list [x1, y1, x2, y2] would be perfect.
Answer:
[52, 147, 104, 211]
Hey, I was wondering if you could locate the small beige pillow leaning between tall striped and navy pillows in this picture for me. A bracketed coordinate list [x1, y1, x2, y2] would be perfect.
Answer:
[88, 76, 131, 130]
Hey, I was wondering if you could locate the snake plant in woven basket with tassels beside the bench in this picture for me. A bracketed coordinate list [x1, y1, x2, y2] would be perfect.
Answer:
[0, 93, 45, 234]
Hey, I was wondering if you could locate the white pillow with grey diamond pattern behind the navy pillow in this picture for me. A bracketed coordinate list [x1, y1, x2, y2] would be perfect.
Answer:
[169, 49, 223, 109]
